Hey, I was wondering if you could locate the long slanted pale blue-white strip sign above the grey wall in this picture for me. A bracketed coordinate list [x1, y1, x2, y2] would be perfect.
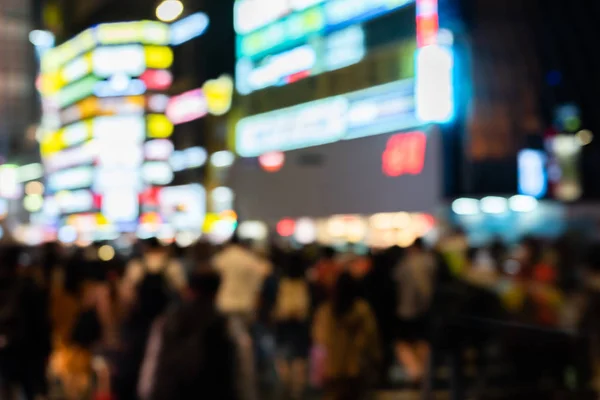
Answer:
[236, 80, 420, 157]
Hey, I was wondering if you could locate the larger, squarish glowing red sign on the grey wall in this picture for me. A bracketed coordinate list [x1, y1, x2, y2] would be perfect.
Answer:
[382, 132, 427, 178]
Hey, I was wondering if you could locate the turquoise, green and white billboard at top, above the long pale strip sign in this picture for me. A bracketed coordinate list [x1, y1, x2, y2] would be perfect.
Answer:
[234, 0, 415, 95]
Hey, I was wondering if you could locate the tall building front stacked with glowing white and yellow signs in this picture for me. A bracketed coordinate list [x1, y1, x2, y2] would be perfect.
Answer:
[38, 20, 182, 234]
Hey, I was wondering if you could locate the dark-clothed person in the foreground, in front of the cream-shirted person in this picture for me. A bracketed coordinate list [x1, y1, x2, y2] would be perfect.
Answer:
[138, 272, 241, 400]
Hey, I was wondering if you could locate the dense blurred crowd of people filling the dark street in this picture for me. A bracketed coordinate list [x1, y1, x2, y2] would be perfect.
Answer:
[0, 232, 600, 400]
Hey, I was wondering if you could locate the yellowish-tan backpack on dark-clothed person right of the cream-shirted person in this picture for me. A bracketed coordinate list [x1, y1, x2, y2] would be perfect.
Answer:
[275, 278, 310, 320]
